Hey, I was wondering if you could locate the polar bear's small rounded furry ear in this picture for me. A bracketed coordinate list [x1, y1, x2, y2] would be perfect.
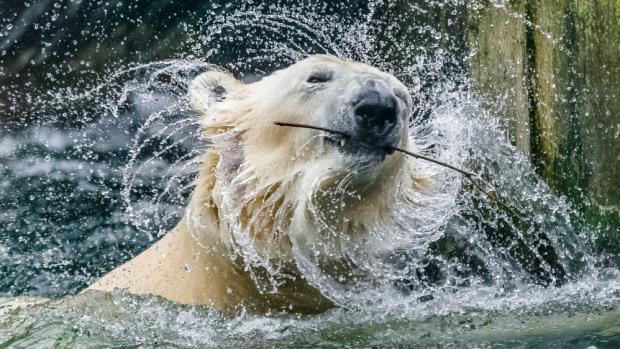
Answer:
[189, 71, 243, 113]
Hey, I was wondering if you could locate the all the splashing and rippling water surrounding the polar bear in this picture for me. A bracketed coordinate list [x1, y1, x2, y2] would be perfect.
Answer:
[0, 1, 620, 348]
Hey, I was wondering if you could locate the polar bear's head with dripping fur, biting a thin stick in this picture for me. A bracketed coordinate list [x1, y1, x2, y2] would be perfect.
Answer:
[188, 56, 424, 274]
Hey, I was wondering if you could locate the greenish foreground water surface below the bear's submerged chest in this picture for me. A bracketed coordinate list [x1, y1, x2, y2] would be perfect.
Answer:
[0, 280, 620, 348]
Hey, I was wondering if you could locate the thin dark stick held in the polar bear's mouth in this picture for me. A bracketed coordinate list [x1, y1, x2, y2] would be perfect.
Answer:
[274, 121, 526, 221]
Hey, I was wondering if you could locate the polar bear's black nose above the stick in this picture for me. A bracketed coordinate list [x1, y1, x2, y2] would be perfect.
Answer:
[354, 91, 398, 136]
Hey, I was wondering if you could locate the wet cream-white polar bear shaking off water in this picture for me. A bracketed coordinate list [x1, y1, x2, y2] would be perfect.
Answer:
[89, 55, 421, 314]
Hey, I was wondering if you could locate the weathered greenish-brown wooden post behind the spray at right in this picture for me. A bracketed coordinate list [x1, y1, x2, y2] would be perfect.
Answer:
[469, 0, 620, 251]
